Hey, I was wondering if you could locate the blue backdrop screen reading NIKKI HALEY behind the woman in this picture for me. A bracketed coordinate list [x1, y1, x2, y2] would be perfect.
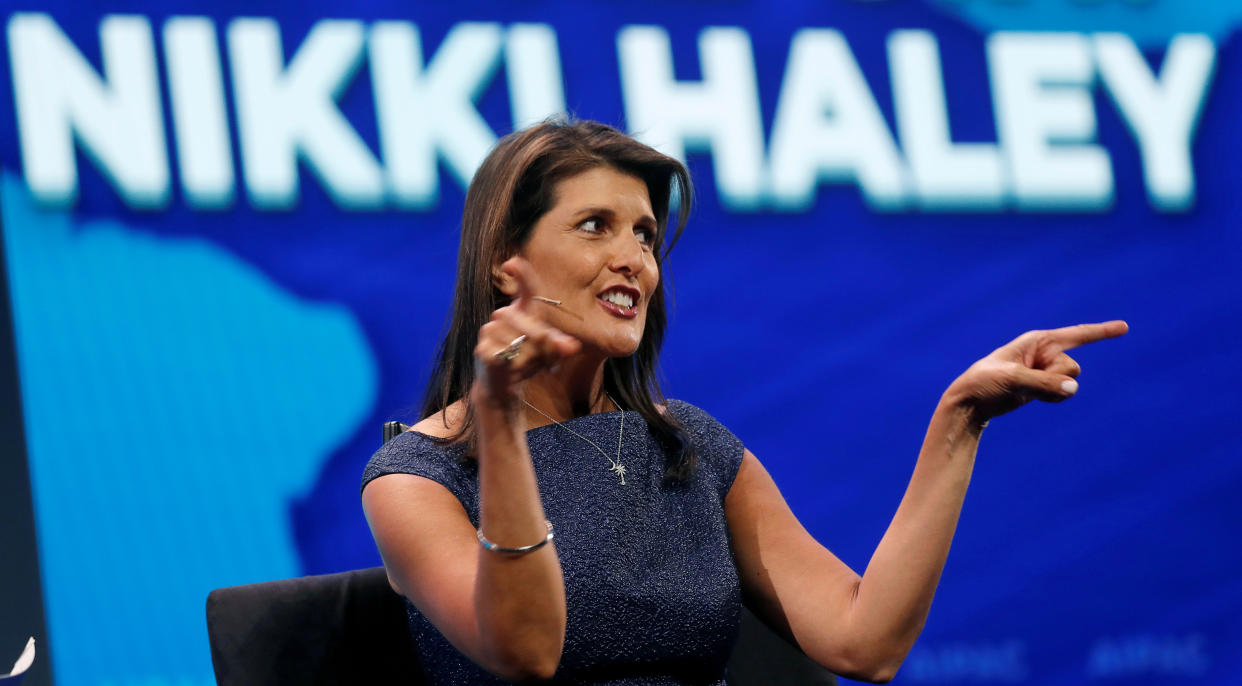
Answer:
[0, 0, 1242, 686]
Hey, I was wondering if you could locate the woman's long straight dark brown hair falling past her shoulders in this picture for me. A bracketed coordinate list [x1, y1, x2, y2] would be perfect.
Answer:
[421, 121, 697, 482]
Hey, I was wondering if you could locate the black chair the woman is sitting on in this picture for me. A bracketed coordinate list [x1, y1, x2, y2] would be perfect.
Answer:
[207, 421, 837, 686]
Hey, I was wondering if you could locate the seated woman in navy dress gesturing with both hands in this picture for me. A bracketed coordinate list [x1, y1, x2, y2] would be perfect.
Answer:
[363, 122, 1126, 684]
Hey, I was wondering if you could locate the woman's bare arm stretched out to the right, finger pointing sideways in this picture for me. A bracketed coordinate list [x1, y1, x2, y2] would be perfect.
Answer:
[725, 322, 1126, 682]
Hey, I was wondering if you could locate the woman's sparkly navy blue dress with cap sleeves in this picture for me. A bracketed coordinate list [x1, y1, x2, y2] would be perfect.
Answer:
[363, 400, 743, 686]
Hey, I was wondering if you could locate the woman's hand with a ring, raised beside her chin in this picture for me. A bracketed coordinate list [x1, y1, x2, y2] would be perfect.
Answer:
[472, 256, 582, 408]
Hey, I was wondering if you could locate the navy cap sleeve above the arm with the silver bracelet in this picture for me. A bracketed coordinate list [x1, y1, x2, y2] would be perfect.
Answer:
[361, 431, 478, 523]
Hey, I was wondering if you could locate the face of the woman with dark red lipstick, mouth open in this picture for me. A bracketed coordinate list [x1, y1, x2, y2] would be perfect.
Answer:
[505, 167, 660, 357]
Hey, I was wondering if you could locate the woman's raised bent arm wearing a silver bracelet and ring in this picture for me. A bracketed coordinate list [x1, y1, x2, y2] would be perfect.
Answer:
[363, 257, 579, 680]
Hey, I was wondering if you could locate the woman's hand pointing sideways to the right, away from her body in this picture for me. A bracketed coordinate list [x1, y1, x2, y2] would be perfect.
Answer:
[945, 319, 1130, 426]
